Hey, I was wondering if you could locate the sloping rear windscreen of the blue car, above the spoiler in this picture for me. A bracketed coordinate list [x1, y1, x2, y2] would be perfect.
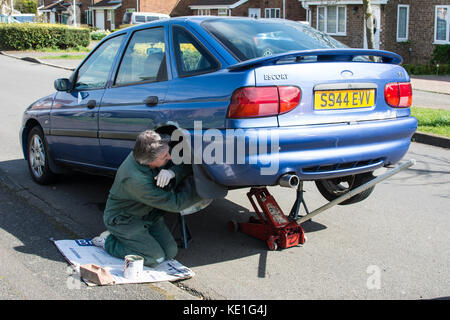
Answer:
[201, 19, 347, 61]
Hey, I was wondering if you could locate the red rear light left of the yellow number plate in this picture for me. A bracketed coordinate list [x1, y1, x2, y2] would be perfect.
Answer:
[227, 86, 301, 119]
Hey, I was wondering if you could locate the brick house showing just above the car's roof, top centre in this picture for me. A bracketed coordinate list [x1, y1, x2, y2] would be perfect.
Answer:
[189, 0, 306, 21]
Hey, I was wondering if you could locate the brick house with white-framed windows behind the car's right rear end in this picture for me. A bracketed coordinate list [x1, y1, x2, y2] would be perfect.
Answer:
[298, 0, 450, 63]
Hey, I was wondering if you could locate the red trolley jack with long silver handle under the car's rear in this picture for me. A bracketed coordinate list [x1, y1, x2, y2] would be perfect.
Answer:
[229, 159, 416, 250]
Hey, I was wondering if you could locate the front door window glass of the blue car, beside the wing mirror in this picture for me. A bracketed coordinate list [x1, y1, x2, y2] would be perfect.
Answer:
[75, 35, 125, 90]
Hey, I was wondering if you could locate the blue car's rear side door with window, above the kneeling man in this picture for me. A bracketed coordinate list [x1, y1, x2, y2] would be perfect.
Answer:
[99, 25, 169, 168]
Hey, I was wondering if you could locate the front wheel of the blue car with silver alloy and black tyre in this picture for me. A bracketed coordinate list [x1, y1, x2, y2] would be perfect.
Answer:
[27, 126, 56, 185]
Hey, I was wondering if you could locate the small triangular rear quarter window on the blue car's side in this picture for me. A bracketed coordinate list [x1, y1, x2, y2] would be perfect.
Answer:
[173, 26, 220, 77]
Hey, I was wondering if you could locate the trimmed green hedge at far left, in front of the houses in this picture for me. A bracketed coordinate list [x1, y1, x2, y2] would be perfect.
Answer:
[0, 23, 90, 50]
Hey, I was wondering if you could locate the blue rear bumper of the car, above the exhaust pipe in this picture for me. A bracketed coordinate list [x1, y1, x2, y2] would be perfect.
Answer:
[191, 117, 417, 187]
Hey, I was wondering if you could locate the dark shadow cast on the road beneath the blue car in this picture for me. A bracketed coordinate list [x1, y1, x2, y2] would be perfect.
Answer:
[0, 159, 326, 277]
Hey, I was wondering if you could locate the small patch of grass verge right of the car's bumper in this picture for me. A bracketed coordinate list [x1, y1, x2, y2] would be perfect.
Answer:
[411, 107, 450, 138]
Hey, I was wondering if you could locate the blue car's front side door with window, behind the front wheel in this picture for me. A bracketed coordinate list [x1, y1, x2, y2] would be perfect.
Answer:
[47, 34, 125, 165]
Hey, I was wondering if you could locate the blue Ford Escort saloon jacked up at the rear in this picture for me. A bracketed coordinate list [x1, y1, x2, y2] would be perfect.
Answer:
[21, 16, 417, 204]
